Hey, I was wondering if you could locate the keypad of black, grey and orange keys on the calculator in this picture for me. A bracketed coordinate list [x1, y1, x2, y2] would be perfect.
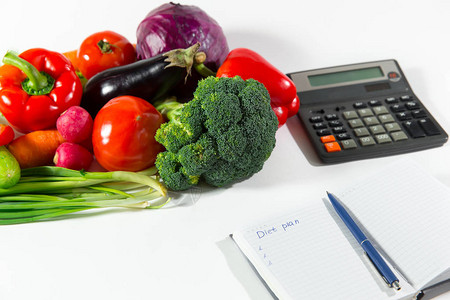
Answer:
[309, 95, 440, 153]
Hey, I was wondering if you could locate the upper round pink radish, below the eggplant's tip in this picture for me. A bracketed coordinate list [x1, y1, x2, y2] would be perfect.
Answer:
[56, 106, 94, 143]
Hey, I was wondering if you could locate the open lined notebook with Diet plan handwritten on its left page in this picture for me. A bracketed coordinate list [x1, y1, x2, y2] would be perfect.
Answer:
[231, 160, 450, 300]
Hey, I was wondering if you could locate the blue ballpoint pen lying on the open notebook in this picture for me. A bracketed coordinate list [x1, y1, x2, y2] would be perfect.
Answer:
[327, 192, 401, 291]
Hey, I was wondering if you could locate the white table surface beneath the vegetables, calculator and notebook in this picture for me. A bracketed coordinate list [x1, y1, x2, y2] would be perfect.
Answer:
[0, 0, 450, 300]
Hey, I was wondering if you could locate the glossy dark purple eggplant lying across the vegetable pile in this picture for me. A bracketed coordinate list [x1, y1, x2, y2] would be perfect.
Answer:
[80, 43, 200, 118]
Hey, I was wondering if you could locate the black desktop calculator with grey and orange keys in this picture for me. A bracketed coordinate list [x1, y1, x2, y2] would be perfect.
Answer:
[287, 59, 448, 163]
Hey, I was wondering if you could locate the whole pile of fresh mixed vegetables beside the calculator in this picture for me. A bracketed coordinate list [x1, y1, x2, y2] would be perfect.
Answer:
[0, 3, 300, 225]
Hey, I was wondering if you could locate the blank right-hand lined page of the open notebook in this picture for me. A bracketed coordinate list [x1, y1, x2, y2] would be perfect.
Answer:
[338, 161, 450, 287]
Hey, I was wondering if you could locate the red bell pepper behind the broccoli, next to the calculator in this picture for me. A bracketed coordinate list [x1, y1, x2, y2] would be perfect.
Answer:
[216, 48, 300, 127]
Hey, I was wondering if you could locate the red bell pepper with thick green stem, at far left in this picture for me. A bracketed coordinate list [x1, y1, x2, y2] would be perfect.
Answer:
[0, 48, 83, 133]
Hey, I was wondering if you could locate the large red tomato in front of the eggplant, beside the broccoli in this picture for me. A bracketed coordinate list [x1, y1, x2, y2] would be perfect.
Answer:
[92, 96, 164, 172]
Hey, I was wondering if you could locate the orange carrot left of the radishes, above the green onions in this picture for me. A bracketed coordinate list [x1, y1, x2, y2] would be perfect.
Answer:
[8, 129, 65, 169]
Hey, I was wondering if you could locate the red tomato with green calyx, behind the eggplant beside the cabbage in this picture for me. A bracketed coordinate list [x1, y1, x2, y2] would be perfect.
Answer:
[76, 31, 136, 79]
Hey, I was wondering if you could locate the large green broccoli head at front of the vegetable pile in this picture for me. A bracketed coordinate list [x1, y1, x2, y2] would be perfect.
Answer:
[156, 76, 278, 190]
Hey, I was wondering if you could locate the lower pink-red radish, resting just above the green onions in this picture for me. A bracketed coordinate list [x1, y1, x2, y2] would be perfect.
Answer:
[53, 142, 93, 170]
